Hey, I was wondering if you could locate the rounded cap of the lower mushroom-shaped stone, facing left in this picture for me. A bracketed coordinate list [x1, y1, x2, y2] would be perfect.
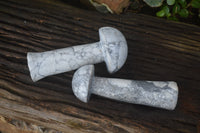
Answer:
[72, 65, 94, 103]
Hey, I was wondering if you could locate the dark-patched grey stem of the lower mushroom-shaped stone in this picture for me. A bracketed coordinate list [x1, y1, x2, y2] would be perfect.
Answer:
[91, 77, 178, 110]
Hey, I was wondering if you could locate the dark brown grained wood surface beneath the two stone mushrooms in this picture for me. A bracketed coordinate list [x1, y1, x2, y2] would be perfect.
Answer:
[0, 0, 200, 133]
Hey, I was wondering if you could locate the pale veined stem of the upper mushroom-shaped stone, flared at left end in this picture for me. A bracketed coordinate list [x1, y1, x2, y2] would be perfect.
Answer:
[27, 42, 103, 81]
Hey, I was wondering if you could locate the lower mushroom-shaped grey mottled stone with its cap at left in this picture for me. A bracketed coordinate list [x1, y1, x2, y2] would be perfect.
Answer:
[72, 65, 178, 110]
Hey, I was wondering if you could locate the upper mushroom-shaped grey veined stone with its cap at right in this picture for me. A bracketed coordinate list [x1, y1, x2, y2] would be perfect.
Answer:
[27, 27, 128, 82]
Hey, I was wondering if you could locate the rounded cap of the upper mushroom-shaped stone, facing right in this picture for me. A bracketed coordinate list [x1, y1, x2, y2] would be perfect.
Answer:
[99, 27, 128, 73]
